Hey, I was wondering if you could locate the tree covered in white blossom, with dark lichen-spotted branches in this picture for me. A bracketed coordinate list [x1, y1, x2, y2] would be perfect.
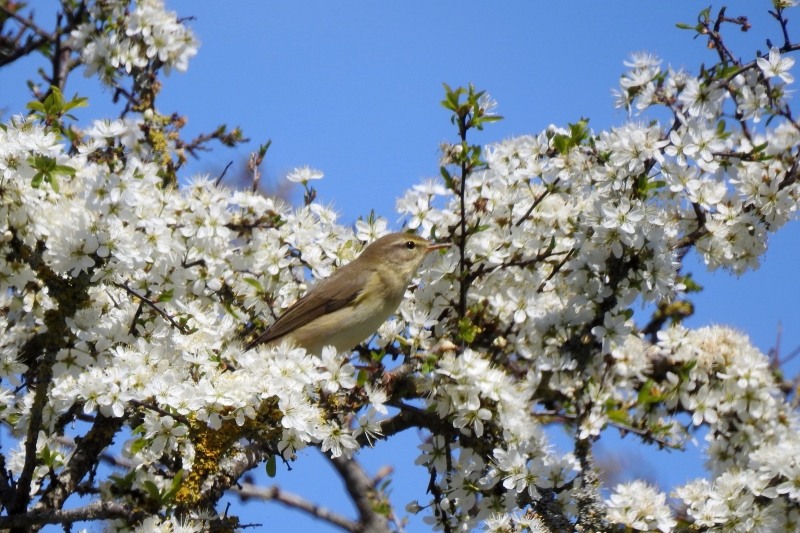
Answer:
[0, 0, 800, 532]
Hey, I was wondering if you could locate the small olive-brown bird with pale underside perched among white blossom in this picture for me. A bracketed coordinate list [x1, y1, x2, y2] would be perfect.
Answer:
[245, 233, 450, 355]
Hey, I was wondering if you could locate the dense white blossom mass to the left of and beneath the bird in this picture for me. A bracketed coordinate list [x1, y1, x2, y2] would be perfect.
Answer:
[0, 111, 368, 527]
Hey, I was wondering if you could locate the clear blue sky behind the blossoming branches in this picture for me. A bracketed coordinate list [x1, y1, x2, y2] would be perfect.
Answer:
[0, 0, 800, 531]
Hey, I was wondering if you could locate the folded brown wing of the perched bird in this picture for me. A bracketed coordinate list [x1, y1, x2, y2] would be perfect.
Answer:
[245, 263, 372, 351]
